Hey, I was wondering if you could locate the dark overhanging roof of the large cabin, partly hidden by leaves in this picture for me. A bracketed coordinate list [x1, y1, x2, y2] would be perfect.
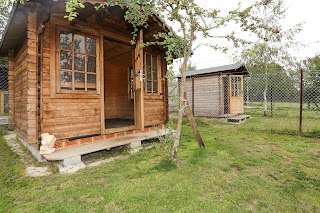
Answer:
[0, 0, 171, 56]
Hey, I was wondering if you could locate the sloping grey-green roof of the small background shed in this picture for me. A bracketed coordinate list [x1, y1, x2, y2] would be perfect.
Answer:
[176, 63, 249, 78]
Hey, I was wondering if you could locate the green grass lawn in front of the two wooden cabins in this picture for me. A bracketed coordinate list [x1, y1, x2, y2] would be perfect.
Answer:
[0, 113, 320, 212]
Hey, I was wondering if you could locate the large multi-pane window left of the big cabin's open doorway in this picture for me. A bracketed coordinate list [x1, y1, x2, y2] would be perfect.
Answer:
[58, 31, 97, 91]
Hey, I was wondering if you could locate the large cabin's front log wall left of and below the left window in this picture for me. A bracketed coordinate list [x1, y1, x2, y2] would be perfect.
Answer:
[41, 20, 101, 139]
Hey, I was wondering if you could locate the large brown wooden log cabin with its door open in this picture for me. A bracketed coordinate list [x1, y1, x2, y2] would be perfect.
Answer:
[0, 0, 168, 162]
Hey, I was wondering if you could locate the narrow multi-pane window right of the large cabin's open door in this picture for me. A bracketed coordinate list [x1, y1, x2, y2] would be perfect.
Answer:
[143, 53, 159, 94]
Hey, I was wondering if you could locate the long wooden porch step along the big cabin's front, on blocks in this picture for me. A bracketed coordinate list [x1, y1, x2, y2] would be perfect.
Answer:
[43, 129, 170, 161]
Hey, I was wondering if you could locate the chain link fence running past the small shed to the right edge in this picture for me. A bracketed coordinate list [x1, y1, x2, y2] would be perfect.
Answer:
[169, 70, 320, 134]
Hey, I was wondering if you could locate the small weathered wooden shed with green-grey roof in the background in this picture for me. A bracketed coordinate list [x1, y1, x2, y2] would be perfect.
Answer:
[177, 63, 249, 117]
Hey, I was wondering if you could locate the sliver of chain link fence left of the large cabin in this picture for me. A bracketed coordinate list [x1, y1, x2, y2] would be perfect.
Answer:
[0, 65, 9, 132]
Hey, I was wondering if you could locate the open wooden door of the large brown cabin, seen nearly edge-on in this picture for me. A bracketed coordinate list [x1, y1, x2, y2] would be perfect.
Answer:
[134, 30, 144, 130]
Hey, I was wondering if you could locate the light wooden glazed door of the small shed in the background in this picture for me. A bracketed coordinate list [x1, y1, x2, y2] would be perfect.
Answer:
[229, 75, 244, 114]
